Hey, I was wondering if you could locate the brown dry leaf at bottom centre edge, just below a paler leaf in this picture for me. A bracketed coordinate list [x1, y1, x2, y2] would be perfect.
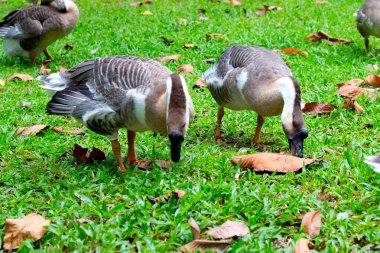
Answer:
[178, 240, 232, 252]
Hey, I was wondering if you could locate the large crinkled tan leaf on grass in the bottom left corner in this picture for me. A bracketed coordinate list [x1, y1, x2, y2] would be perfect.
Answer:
[3, 213, 51, 251]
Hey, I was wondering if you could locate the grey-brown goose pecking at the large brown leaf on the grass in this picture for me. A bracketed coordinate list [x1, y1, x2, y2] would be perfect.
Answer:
[203, 45, 308, 157]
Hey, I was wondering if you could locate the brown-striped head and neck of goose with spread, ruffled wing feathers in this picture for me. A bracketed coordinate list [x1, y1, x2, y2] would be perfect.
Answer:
[166, 74, 193, 162]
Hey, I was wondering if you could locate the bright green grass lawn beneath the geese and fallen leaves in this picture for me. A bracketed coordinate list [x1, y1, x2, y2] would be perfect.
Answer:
[0, 0, 380, 252]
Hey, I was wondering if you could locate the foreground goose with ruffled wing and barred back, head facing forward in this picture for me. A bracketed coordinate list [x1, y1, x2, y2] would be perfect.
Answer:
[38, 56, 194, 173]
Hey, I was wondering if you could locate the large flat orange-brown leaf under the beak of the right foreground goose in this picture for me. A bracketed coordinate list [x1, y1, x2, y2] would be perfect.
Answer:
[231, 153, 315, 173]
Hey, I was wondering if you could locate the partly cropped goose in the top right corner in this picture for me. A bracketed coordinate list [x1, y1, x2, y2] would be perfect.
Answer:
[356, 0, 380, 52]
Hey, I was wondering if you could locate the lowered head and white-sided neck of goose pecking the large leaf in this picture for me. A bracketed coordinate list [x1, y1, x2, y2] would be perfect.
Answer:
[277, 77, 309, 158]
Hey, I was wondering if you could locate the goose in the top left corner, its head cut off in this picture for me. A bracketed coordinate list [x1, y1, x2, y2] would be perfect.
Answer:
[0, 0, 79, 65]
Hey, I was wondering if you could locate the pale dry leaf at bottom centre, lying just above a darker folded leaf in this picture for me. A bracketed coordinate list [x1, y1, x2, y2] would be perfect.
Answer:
[206, 220, 249, 239]
